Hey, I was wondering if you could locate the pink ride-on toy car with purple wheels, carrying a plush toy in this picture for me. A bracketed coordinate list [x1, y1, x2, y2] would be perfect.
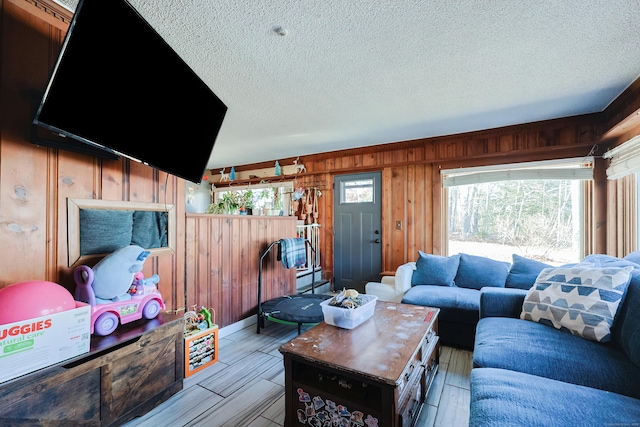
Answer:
[74, 265, 166, 336]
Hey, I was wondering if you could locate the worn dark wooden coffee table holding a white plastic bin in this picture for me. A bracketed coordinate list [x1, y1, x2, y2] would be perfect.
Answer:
[279, 301, 440, 427]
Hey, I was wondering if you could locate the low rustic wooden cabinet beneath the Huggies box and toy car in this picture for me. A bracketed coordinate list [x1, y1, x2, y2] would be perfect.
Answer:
[0, 313, 184, 426]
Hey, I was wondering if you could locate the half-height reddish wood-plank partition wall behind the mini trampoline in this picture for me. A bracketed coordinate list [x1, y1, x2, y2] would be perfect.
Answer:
[186, 214, 296, 326]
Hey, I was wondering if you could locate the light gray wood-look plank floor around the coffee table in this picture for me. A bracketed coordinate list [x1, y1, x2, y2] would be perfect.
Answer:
[125, 322, 471, 427]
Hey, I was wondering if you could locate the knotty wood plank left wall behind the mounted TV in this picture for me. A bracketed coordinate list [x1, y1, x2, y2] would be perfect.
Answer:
[0, 0, 185, 308]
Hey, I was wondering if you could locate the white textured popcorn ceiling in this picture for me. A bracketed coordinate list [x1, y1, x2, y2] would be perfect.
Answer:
[53, 0, 640, 168]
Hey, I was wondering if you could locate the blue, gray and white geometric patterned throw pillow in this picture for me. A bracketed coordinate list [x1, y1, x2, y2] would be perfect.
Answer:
[520, 265, 633, 342]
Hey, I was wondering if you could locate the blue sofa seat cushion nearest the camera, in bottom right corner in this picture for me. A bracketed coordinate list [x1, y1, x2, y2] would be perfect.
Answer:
[469, 368, 640, 427]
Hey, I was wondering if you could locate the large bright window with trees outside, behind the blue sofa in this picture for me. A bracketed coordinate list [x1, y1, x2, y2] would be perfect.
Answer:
[442, 158, 593, 265]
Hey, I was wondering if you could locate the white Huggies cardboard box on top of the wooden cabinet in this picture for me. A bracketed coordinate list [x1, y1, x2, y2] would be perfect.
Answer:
[0, 301, 91, 383]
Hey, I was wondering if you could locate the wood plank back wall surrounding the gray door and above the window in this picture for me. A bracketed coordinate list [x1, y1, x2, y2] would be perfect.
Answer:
[241, 115, 605, 279]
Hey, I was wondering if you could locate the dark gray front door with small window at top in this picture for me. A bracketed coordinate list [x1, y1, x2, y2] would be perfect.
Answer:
[333, 172, 382, 293]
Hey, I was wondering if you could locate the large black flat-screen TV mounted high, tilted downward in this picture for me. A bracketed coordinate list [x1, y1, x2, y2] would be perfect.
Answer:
[33, 0, 227, 183]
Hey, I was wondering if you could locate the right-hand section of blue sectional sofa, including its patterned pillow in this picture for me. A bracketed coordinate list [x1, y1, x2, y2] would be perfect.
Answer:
[469, 253, 640, 427]
